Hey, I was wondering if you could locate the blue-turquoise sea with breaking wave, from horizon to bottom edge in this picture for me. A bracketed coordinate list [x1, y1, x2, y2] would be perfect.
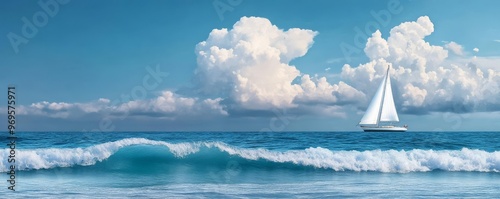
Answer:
[0, 132, 500, 198]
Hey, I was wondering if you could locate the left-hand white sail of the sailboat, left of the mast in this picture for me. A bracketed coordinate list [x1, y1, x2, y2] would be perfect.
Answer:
[359, 73, 386, 125]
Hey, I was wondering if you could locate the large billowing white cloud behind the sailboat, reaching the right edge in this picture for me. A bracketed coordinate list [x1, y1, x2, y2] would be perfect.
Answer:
[341, 16, 500, 113]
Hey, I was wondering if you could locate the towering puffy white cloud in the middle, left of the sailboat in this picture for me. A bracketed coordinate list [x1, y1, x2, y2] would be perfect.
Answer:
[196, 17, 364, 110]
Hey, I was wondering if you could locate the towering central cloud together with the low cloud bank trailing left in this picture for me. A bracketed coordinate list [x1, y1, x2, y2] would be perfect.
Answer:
[5, 17, 366, 121]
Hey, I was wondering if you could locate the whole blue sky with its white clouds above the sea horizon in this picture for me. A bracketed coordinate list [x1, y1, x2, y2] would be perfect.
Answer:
[0, 0, 500, 132]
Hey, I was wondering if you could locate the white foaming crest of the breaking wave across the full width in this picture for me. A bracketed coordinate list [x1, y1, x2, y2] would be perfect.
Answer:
[0, 138, 500, 173]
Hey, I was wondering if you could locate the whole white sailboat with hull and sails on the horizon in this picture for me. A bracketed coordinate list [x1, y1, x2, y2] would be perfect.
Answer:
[359, 66, 408, 132]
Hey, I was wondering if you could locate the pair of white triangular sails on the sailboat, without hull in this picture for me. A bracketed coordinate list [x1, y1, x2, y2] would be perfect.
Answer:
[359, 68, 399, 125]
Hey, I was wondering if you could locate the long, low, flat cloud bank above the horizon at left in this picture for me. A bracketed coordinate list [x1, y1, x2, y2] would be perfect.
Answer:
[18, 90, 227, 119]
